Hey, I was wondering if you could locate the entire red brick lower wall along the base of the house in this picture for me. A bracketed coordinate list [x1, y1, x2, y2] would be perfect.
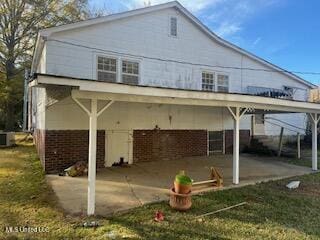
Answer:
[34, 130, 250, 173]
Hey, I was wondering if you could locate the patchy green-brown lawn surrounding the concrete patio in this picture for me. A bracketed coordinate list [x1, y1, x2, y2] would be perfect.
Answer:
[0, 136, 320, 240]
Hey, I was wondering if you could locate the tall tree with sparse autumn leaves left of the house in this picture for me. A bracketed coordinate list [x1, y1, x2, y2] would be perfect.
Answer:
[0, 0, 90, 130]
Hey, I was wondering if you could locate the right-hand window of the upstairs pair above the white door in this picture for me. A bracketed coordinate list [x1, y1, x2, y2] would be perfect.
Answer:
[122, 60, 139, 85]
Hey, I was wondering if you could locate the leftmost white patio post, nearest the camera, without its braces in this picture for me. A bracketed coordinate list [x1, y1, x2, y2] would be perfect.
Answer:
[87, 99, 97, 216]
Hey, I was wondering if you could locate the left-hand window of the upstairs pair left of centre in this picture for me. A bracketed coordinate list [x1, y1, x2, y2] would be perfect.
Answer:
[97, 56, 117, 82]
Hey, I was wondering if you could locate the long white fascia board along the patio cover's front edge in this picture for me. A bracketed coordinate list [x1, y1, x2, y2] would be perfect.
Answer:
[37, 75, 320, 113]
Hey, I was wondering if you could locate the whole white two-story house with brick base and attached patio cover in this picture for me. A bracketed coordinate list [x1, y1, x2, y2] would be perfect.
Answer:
[29, 2, 320, 214]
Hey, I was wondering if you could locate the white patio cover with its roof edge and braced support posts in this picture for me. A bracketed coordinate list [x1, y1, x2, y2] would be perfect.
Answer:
[29, 74, 320, 215]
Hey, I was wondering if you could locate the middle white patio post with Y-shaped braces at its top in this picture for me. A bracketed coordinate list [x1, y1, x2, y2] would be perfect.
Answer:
[228, 107, 247, 184]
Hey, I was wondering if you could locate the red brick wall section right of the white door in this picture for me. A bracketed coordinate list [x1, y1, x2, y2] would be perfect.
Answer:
[133, 130, 207, 162]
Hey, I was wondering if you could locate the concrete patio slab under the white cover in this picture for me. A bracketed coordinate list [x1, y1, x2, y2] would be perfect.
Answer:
[47, 155, 311, 216]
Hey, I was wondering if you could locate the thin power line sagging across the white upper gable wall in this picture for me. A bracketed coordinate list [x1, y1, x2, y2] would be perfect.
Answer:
[47, 38, 320, 75]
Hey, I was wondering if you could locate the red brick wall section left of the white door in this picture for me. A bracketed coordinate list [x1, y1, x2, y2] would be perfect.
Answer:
[42, 130, 105, 173]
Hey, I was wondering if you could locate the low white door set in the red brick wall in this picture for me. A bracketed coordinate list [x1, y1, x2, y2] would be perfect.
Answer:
[105, 131, 132, 167]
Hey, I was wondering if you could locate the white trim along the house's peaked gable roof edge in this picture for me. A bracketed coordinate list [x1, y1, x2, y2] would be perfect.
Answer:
[32, 1, 316, 88]
